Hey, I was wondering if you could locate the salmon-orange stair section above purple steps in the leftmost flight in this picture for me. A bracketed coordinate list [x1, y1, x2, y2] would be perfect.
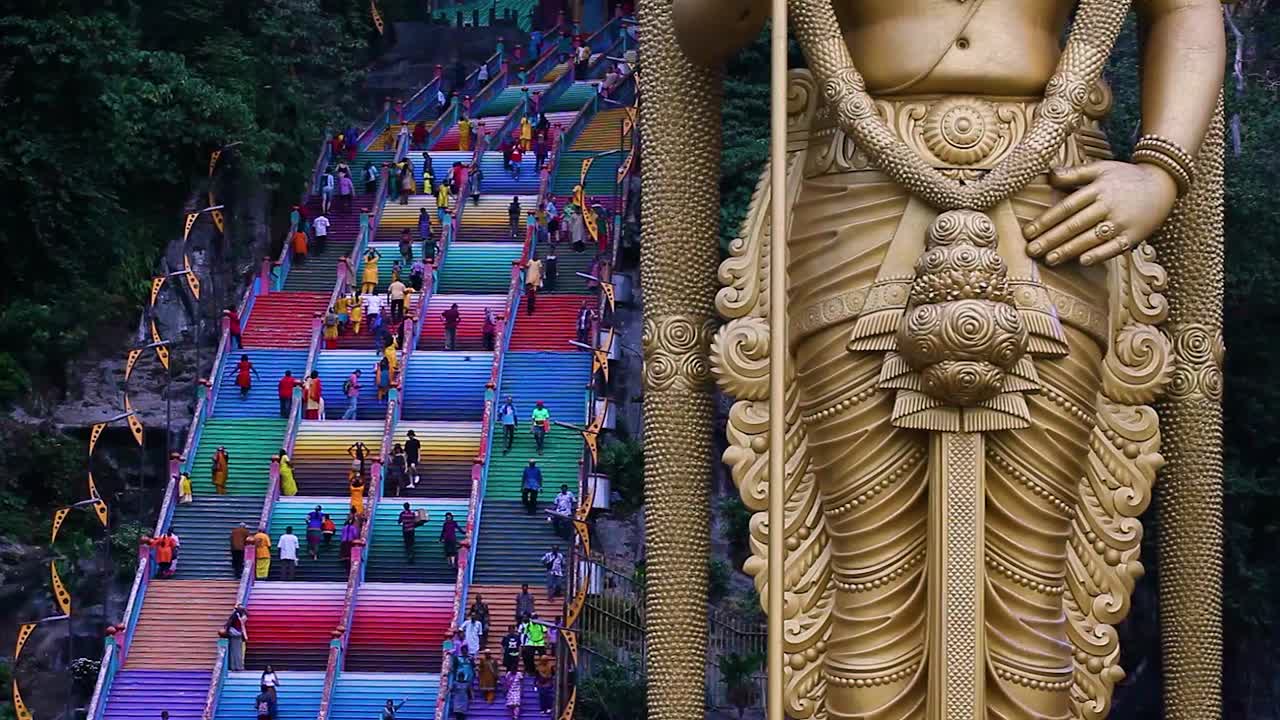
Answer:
[124, 579, 239, 673]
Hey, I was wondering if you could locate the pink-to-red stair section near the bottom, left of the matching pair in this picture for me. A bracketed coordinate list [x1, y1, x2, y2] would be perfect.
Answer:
[244, 576, 347, 666]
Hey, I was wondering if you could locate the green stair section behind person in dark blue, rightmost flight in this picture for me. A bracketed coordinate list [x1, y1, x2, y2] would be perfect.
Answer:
[481, 425, 582, 499]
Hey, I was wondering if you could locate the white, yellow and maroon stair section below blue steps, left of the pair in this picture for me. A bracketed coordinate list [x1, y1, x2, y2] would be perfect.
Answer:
[292, 420, 385, 497]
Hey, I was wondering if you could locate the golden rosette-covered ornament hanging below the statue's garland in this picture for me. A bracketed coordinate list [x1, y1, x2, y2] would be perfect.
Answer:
[851, 210, 1066, 432]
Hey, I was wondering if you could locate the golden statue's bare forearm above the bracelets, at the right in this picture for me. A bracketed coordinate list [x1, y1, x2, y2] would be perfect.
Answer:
[1139, 0, 1226, 155]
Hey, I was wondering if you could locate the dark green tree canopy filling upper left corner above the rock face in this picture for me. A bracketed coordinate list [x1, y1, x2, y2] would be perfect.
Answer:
[0, 0, 370, 401]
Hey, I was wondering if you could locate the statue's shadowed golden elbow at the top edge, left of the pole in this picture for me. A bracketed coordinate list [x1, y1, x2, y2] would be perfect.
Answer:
[672, 0, 769, 65]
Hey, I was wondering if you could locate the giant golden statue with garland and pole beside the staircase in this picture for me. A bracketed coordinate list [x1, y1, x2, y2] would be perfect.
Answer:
[637, 0, 1225, 720]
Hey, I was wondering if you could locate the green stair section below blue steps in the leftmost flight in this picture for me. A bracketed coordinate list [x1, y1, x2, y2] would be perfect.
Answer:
[191, 418, 288, 496]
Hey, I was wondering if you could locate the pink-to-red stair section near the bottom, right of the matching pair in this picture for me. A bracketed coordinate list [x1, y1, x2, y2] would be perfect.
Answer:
[346, 579, 453, 671]
